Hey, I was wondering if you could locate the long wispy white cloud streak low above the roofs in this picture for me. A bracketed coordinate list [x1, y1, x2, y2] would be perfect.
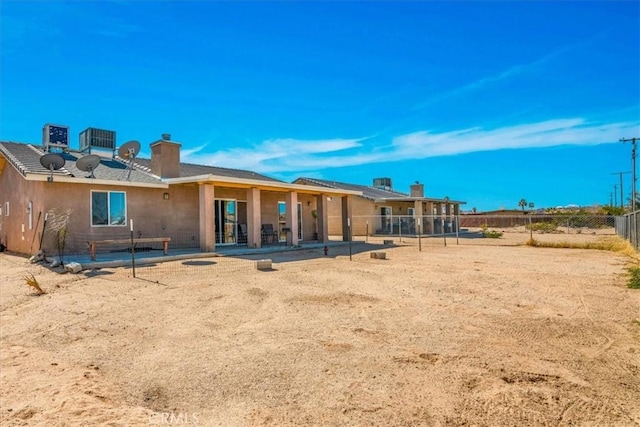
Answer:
[182, 118, 640, 174]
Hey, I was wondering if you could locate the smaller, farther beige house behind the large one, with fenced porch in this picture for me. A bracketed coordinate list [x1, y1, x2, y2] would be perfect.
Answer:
[294, 177, 466, 236]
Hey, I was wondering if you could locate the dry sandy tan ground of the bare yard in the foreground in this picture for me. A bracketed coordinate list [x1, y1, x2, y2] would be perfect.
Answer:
[0, 234, 640, 426]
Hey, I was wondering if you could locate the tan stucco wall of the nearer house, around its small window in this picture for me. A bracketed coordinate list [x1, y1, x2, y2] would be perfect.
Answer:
[0, 162, 340, 255]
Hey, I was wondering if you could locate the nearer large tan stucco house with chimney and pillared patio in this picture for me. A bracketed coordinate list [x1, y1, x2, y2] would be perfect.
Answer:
[0, 134, 361, 254]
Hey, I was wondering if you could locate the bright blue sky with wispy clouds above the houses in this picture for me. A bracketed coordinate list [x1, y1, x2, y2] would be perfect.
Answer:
[0, 0, 640, 210]
